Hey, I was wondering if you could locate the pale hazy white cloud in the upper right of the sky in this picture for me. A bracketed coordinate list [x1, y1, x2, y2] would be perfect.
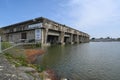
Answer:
[69, 0, 120, 28]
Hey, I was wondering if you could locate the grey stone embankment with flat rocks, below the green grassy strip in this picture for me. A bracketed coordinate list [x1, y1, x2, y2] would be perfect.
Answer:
[0, 55, 41, 80]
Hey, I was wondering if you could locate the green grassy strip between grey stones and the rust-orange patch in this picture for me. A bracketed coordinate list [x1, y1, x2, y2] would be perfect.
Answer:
[4, 49, 45, 72]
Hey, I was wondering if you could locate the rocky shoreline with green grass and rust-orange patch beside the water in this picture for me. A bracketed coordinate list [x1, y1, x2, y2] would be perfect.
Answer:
[0, 49, 67, 80]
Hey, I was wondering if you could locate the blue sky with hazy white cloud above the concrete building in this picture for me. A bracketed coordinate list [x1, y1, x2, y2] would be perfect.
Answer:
[0, 0, 120, 38]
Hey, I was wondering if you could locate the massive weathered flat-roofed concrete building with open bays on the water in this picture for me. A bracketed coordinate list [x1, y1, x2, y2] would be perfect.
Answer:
[2, 17, 89, 44]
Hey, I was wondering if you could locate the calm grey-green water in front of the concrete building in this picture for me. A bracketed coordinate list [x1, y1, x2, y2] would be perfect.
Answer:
[36, 42, 120, 80]
